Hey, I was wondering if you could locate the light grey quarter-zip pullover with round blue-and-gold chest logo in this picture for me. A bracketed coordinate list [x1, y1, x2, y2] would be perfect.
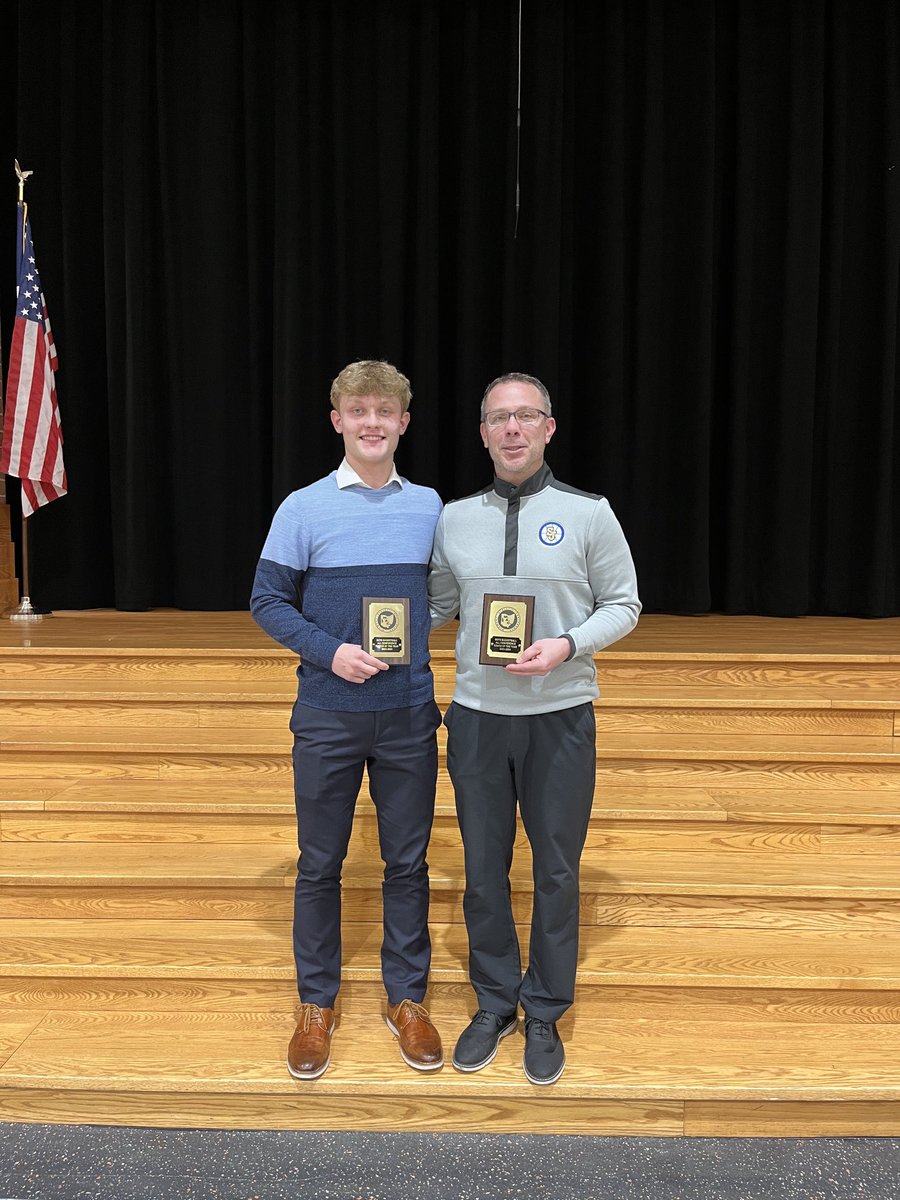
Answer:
[428, 464, 641, 715]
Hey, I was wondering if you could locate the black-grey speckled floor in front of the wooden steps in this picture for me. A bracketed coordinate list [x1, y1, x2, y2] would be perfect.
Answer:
[0, 1124, 900, 1200]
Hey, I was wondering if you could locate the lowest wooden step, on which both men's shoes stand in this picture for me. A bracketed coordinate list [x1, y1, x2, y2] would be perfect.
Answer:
[0, 988, 900, 1134]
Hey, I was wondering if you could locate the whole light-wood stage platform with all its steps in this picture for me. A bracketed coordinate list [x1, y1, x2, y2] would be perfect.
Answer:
[0, 611, 900, 1135]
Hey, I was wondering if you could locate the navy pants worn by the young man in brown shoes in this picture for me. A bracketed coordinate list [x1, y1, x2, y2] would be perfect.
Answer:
[290, 701, 440, 1008]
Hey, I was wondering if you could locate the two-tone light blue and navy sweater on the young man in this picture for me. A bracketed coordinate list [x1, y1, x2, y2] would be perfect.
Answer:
[250, 472, 440, 712]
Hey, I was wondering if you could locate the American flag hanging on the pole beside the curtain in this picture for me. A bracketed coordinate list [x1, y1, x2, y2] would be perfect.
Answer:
[0, 204, 67, 517]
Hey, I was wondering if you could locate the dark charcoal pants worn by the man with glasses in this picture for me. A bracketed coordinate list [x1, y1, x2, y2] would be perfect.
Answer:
[444, 703, 596, 1021]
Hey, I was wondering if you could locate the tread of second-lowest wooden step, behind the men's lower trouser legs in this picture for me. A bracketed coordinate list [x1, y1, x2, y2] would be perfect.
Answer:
[0, 918, 900, 998]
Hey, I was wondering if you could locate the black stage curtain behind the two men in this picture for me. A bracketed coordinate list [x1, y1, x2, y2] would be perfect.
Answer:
[0, 0, 900, 617]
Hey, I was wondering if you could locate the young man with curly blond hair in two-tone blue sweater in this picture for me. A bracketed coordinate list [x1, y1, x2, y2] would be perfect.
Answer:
[251, 361, 444, 1079]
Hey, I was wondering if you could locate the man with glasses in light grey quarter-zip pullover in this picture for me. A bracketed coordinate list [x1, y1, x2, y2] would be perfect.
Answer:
[428, 372, 641, 1084]
